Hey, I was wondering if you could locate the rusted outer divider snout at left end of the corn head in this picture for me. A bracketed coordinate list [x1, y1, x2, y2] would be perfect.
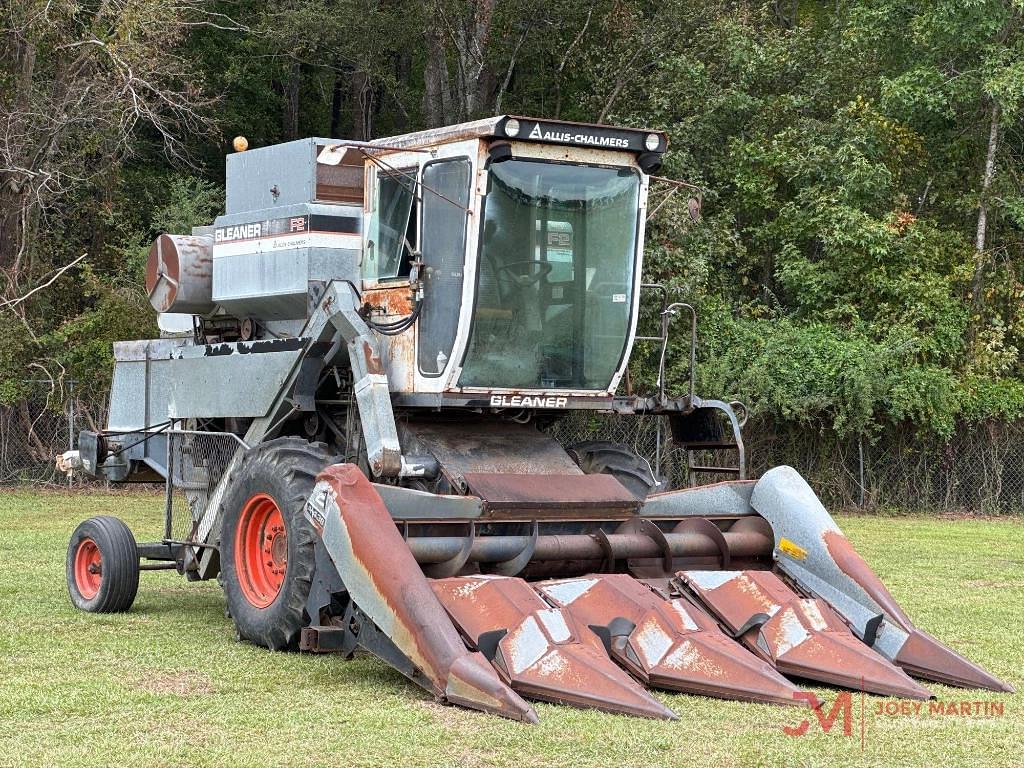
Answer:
[306, 464, 537, 722]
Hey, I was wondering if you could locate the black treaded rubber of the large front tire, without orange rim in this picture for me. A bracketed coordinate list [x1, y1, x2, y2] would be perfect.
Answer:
[218, 437, 338, 650]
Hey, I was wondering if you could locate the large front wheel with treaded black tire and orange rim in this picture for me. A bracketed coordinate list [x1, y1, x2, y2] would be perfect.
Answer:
[220, 437, 333, 650]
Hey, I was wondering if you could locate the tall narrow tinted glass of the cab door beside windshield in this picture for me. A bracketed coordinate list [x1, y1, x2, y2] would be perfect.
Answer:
[418, 159, 471, 376]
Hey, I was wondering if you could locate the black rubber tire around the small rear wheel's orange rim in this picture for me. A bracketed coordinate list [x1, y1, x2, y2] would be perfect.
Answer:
[66, 515, 139, 613]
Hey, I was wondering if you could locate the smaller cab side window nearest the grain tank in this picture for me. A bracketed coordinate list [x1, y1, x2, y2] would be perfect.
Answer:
[362, 168, 416, 280]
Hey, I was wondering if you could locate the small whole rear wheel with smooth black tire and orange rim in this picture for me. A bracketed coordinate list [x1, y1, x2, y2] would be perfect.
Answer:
[67, 515, 139, 613]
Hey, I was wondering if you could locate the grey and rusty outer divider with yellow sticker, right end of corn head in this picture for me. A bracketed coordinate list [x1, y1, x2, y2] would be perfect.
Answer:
[737, 467, 1013, 691]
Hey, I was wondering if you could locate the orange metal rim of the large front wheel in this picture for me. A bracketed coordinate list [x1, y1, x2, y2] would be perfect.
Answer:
[234, 494, 288, 608]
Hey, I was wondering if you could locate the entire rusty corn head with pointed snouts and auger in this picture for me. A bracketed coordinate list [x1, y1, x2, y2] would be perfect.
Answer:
[304, 465, 1009, 722]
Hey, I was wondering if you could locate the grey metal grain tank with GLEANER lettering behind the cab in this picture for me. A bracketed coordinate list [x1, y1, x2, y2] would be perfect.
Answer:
[213, 138, 364, 321]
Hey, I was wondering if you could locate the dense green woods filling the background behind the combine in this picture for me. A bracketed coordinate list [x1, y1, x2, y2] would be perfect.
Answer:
[0, 0, 1024, 434]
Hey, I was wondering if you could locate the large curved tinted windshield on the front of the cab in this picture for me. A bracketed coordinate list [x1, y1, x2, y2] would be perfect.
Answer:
[459, 160, 640, 389]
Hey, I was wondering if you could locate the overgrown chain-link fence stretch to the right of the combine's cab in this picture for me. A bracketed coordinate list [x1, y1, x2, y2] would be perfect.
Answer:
[550, 414, 1024, 515]
